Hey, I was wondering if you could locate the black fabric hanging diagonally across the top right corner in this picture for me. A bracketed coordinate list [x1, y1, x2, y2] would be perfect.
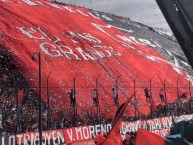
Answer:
[156, 0, 193, 68]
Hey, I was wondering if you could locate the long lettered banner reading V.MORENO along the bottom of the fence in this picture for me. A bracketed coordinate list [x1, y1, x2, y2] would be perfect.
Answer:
[0, 115, 193, 145]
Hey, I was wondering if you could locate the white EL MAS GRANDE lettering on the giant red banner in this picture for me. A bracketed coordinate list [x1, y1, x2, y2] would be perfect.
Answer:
[17, 27, 121, 61]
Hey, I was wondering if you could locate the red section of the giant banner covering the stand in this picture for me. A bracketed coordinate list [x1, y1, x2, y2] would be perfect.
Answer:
[0, 0, 188, 118]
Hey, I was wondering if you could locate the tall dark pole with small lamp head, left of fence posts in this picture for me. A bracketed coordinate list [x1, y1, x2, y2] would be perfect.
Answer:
[31, 52, 42, 145]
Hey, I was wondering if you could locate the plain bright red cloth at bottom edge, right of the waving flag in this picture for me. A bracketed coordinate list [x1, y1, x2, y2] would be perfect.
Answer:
[134, 129, 165, 145]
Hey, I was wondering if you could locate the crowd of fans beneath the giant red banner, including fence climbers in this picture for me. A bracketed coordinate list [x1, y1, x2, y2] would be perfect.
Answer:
[0, 52, 193, 139]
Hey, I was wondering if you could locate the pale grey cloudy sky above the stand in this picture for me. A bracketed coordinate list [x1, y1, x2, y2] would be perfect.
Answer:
[57, 0, 171, 31]
